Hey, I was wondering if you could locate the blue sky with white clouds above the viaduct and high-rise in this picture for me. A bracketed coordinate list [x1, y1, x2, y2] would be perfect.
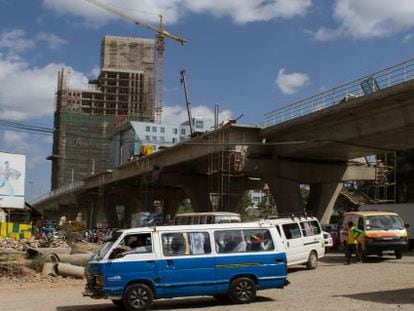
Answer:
[0, 0, 414, 202]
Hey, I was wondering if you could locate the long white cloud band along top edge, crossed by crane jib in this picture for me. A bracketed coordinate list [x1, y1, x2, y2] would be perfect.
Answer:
[43, 0, 312, 24]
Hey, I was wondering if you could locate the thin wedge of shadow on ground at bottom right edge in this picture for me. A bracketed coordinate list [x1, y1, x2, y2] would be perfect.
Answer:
[333, 287, 414, 304]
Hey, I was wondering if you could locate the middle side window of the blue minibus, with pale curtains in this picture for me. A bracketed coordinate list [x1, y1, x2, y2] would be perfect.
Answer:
[162, 232, 211, 256]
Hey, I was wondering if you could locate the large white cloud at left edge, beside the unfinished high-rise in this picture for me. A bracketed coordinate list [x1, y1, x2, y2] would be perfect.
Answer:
[0, 29, 88, 120]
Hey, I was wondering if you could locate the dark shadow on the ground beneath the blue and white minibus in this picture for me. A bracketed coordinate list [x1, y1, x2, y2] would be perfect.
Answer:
[57, 296, 273, 311]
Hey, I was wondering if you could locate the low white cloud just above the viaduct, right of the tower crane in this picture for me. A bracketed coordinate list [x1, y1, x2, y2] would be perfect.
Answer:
[162, 105, 231, 125]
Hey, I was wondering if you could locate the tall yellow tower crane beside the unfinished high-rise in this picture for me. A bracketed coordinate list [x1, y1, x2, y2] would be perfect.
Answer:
[85, 0, 188, 123]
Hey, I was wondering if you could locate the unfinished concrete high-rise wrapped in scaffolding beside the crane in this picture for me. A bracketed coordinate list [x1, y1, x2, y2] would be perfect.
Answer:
[50, 36, 155, 189]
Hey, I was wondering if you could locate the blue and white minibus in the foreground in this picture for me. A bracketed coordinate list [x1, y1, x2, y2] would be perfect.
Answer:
[84, 223, 288, 310]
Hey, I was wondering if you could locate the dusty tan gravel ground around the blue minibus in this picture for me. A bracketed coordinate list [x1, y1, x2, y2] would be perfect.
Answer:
[0, 252, 414, 311]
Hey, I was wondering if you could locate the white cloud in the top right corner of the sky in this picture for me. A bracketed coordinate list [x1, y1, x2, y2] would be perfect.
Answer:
[312, 0, 414, 41]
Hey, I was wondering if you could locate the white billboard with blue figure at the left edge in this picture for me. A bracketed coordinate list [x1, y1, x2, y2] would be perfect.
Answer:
[0, 152, 26, 208]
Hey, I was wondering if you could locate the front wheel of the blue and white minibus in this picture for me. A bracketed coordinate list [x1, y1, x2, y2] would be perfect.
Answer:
[122, 283, 154, 311]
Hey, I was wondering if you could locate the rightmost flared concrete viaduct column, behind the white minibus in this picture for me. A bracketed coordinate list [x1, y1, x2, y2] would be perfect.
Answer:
[306, 182, 343, 224]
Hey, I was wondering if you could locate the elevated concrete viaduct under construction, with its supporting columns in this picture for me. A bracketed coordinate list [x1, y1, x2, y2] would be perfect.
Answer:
[33, 81, 414, 226]
